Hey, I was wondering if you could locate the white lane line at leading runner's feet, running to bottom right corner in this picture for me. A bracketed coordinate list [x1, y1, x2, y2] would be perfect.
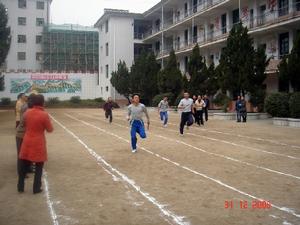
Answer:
[65, 113, 300, 218]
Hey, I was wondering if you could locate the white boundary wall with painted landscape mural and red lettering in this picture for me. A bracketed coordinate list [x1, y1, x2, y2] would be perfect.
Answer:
[0, 73, 100, 100]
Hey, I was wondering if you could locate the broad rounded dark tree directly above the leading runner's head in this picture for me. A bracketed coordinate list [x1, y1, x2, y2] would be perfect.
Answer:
[130, 51, 160, 104]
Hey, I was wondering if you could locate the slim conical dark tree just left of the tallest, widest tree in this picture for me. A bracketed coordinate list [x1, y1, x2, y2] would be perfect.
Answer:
[187, 44, 208, 94]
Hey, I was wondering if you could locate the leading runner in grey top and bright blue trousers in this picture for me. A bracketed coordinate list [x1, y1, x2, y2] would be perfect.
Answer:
[127, 95, 150, 153]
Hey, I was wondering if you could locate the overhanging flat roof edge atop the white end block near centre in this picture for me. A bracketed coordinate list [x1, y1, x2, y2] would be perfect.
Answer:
[94, 9, 144, 27]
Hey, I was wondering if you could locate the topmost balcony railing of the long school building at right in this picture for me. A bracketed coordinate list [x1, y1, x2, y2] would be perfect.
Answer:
[156, 3, 300, 58]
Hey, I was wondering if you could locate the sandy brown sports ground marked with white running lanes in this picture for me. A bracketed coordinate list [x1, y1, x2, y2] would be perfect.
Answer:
[0, 109, 300, 225]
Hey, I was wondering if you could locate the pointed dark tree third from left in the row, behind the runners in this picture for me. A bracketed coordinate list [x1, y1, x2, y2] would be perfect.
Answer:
[158, 50, 183, 98]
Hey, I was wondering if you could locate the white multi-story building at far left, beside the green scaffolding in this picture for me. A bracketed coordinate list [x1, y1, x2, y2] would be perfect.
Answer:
[0, 0, 52, 71]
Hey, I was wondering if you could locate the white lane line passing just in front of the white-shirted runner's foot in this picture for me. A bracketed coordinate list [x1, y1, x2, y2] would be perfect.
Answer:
[79, 115, 300, 180]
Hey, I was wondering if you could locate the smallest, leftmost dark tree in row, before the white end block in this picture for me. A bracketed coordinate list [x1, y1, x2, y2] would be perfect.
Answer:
[110, 61, 132, 101]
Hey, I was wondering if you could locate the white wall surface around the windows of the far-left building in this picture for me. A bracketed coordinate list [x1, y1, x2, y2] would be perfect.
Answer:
[0, 0, 50, 70]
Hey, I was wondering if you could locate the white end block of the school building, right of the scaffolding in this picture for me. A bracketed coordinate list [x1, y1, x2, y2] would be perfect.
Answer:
[95, 9, 151, 99]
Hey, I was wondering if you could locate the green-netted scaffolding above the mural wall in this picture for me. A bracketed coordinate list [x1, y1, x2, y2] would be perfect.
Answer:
[42, 24, 99, 73]
